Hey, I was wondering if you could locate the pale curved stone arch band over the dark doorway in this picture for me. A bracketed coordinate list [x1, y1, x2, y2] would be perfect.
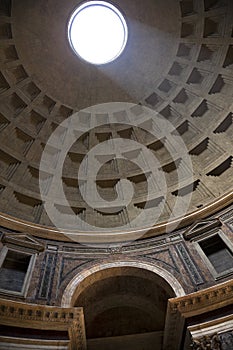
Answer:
[61, 260, 185, 307]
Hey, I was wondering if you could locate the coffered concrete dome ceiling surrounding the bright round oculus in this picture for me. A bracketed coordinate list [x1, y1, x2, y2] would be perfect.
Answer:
[0, 0, 233, 241]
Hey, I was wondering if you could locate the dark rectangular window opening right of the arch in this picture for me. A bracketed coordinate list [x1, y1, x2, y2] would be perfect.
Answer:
[198, 234, 233, 277]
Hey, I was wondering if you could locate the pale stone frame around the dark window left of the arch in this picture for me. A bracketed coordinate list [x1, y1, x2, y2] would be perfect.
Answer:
[0, 245, 36, 297]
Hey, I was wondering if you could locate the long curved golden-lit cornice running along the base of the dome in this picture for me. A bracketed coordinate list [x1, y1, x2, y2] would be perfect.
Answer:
[0, 192, 233, 244]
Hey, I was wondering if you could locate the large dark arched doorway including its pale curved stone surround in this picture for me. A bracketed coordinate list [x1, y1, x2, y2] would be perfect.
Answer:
[63, 262, 184, 350]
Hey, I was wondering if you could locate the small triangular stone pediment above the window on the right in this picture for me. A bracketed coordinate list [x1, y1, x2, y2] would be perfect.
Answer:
[184, 218, 221, 240]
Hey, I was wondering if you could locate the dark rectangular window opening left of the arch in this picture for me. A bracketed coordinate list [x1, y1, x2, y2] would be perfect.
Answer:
[0, 248, 33, 295]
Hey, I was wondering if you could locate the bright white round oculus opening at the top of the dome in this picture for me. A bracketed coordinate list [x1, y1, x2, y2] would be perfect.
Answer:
[68, 1, 128, 65]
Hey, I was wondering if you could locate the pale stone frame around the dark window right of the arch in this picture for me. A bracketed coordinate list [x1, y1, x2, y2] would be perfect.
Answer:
[193, 229, 233, 281]
